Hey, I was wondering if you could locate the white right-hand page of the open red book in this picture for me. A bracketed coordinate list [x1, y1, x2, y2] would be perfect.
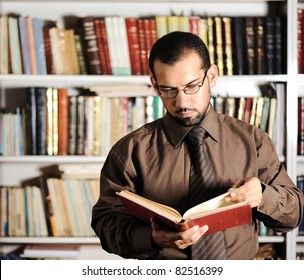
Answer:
[183, 192, 234, 219]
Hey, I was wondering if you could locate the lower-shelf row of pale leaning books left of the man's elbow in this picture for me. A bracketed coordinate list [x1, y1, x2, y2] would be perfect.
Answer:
[0, 173, 99, 237]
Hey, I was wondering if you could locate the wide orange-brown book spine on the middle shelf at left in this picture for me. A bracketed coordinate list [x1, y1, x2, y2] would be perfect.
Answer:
[57, 88, 69, 155]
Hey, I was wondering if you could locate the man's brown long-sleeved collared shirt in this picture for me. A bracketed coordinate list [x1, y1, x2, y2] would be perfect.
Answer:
[92, 108, 303, 259]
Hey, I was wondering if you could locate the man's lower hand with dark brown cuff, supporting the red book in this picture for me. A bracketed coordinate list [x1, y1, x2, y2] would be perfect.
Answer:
[151, 218, 208, 250]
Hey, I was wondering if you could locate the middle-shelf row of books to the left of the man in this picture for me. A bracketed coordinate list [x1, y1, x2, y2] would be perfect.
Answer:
[0, 86, 165, 156]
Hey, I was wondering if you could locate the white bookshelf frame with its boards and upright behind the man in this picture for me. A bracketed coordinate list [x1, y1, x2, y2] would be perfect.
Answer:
[0, 0, 304, 259]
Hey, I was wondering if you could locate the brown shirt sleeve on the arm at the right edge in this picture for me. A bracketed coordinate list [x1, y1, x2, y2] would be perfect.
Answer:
[256, 130, 303, 232]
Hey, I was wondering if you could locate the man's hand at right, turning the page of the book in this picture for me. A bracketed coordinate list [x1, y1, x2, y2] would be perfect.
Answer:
[226, 177, 262, 208]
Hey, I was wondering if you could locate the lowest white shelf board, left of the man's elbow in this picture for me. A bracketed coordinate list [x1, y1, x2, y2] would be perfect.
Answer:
[0, 237, 100, 244]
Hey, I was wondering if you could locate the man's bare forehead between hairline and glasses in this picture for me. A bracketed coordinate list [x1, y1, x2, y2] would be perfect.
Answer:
[154, 51, 204, 86]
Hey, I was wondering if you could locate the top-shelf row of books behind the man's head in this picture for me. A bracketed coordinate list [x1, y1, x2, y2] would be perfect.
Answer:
[0, 15, 285, 75]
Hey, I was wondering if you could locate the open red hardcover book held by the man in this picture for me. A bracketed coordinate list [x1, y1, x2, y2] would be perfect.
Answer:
[116, 190, 252, 234]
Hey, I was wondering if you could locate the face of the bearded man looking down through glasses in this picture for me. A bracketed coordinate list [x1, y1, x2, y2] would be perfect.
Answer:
[151, 51, 217, 126]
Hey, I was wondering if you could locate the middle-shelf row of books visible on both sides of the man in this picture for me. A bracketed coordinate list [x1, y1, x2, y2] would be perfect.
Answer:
[0, 83, 285, 156]
